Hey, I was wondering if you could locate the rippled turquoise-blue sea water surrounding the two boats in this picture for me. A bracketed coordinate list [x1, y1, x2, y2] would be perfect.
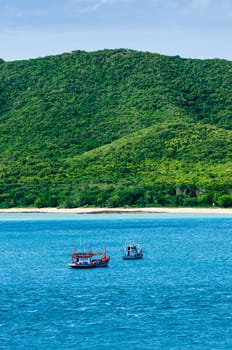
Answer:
[0, 214, 232, 350]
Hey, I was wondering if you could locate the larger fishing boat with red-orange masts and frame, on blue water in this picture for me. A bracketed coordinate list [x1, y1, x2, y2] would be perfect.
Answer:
[68, 248, 110, 269]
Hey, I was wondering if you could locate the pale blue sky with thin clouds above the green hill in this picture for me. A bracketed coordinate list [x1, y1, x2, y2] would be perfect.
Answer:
[0, 0, 232, 61]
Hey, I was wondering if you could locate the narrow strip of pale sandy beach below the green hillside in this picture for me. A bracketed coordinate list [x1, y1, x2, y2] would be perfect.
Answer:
[0, 207, 232, 215]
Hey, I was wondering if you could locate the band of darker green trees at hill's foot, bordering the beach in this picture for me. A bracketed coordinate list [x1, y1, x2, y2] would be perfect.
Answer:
[0, 184, 232, 209]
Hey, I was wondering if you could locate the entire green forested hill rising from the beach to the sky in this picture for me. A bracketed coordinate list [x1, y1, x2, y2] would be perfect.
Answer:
[0, 49, 232, 208]
